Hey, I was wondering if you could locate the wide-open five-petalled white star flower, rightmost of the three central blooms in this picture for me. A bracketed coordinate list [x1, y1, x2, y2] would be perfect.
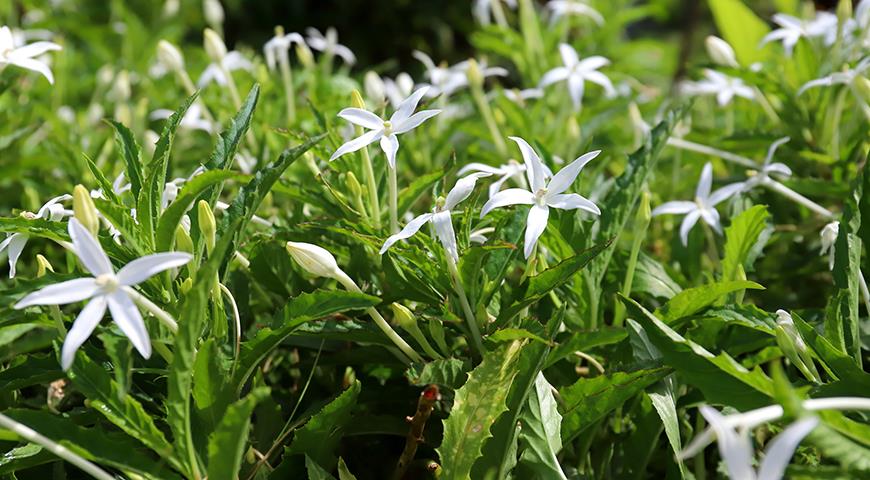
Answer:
[480, 137, 601, 258]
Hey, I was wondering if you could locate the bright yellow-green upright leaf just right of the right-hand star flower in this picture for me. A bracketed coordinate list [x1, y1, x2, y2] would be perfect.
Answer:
[722, 205, 770, 281]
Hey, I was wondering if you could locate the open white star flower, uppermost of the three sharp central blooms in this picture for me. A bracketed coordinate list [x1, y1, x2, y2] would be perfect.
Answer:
[329, 87, 441, 168]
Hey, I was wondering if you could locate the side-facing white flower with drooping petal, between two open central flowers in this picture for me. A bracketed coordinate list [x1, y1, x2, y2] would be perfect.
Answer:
[379, 173, 490, 263]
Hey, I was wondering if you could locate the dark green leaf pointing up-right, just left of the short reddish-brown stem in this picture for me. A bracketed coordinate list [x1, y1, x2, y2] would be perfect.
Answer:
[285, 380, 360, 467]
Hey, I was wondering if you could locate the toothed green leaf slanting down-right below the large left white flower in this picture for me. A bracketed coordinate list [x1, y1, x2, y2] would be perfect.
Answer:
[67, 350, 179, 468]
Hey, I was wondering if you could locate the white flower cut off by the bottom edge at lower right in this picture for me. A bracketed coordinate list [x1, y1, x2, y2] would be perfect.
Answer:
[681, 405, 819, 480]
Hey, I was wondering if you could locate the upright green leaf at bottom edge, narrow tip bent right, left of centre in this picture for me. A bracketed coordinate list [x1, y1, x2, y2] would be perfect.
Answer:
[208, 387, 269, 480]
